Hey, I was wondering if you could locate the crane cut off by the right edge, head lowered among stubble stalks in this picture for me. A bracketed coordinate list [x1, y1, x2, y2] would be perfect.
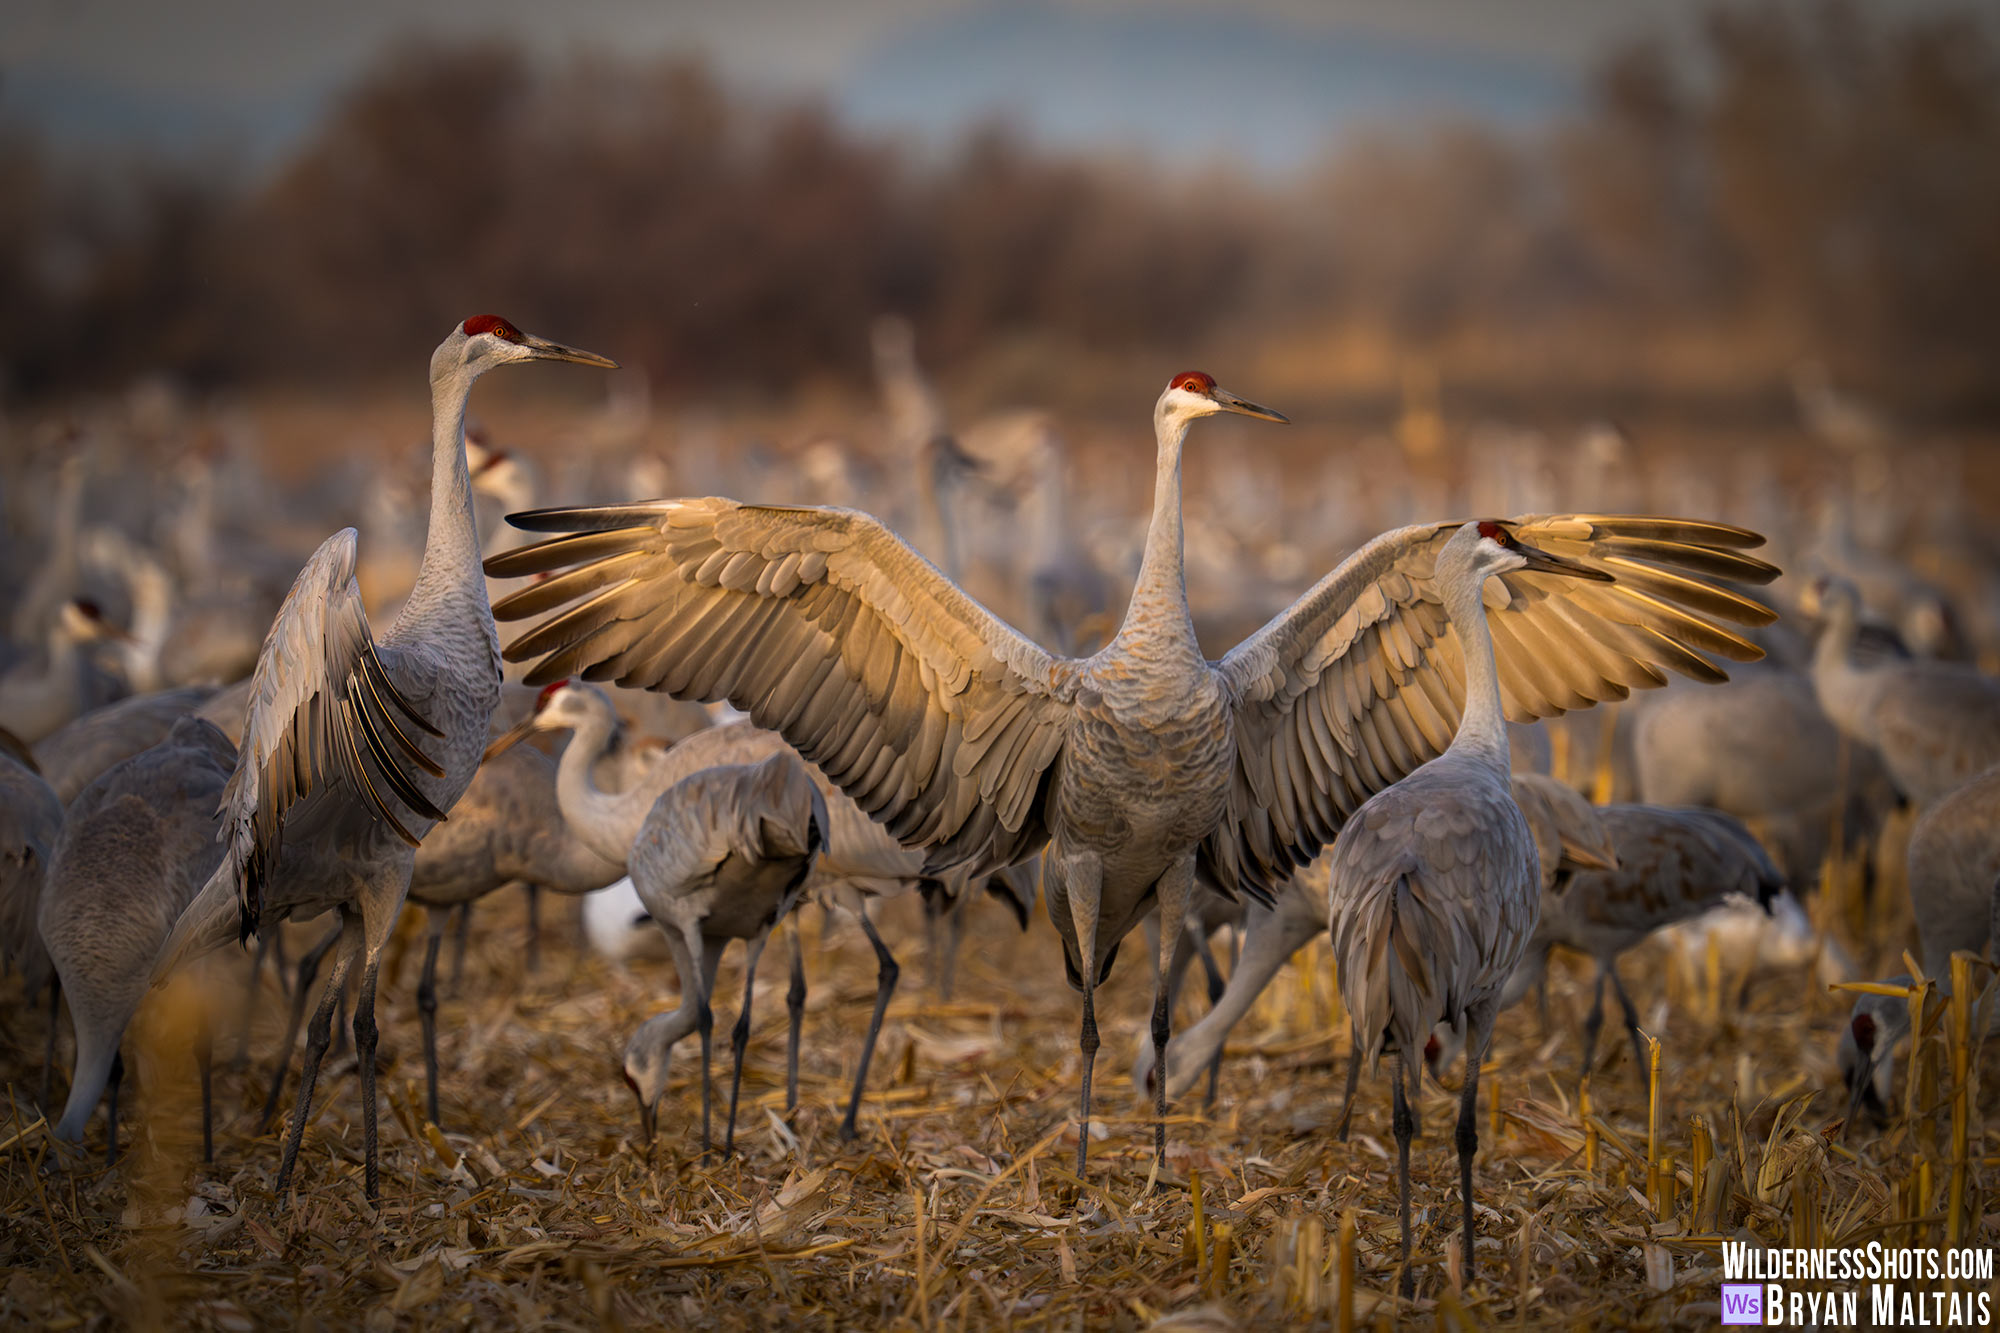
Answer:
[1840, 769, 2000, 1121]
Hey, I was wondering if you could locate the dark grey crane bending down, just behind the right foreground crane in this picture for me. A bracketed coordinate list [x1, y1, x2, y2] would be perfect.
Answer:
[1500, 805, 1786, 1085]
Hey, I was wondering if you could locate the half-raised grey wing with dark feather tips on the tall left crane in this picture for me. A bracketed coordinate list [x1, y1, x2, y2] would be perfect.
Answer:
[220, 528, 444, 937]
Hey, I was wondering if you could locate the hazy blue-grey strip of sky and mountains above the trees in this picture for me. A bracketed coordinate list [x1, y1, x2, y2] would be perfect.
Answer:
[0, 0, 1970, 174]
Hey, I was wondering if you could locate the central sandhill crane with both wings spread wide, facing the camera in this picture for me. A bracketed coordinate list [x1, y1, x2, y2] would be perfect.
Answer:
[486, 372, 1776, 1167]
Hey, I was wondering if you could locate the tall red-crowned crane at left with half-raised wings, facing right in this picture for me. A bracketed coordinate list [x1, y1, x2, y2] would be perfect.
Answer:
[154, 314, 616, 1201]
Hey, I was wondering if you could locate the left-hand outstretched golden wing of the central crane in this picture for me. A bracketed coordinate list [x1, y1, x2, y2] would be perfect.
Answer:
[486, 498, 1076, 873]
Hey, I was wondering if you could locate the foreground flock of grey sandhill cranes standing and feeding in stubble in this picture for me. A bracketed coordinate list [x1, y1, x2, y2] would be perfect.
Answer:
[0, 316, 2000, 1289]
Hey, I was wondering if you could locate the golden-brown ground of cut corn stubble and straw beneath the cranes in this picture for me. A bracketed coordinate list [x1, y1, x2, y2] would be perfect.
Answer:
[0, 852, 2000, 1329]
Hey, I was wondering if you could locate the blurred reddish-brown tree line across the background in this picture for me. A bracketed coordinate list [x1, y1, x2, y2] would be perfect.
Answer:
[0, 4, 2000, 414]
